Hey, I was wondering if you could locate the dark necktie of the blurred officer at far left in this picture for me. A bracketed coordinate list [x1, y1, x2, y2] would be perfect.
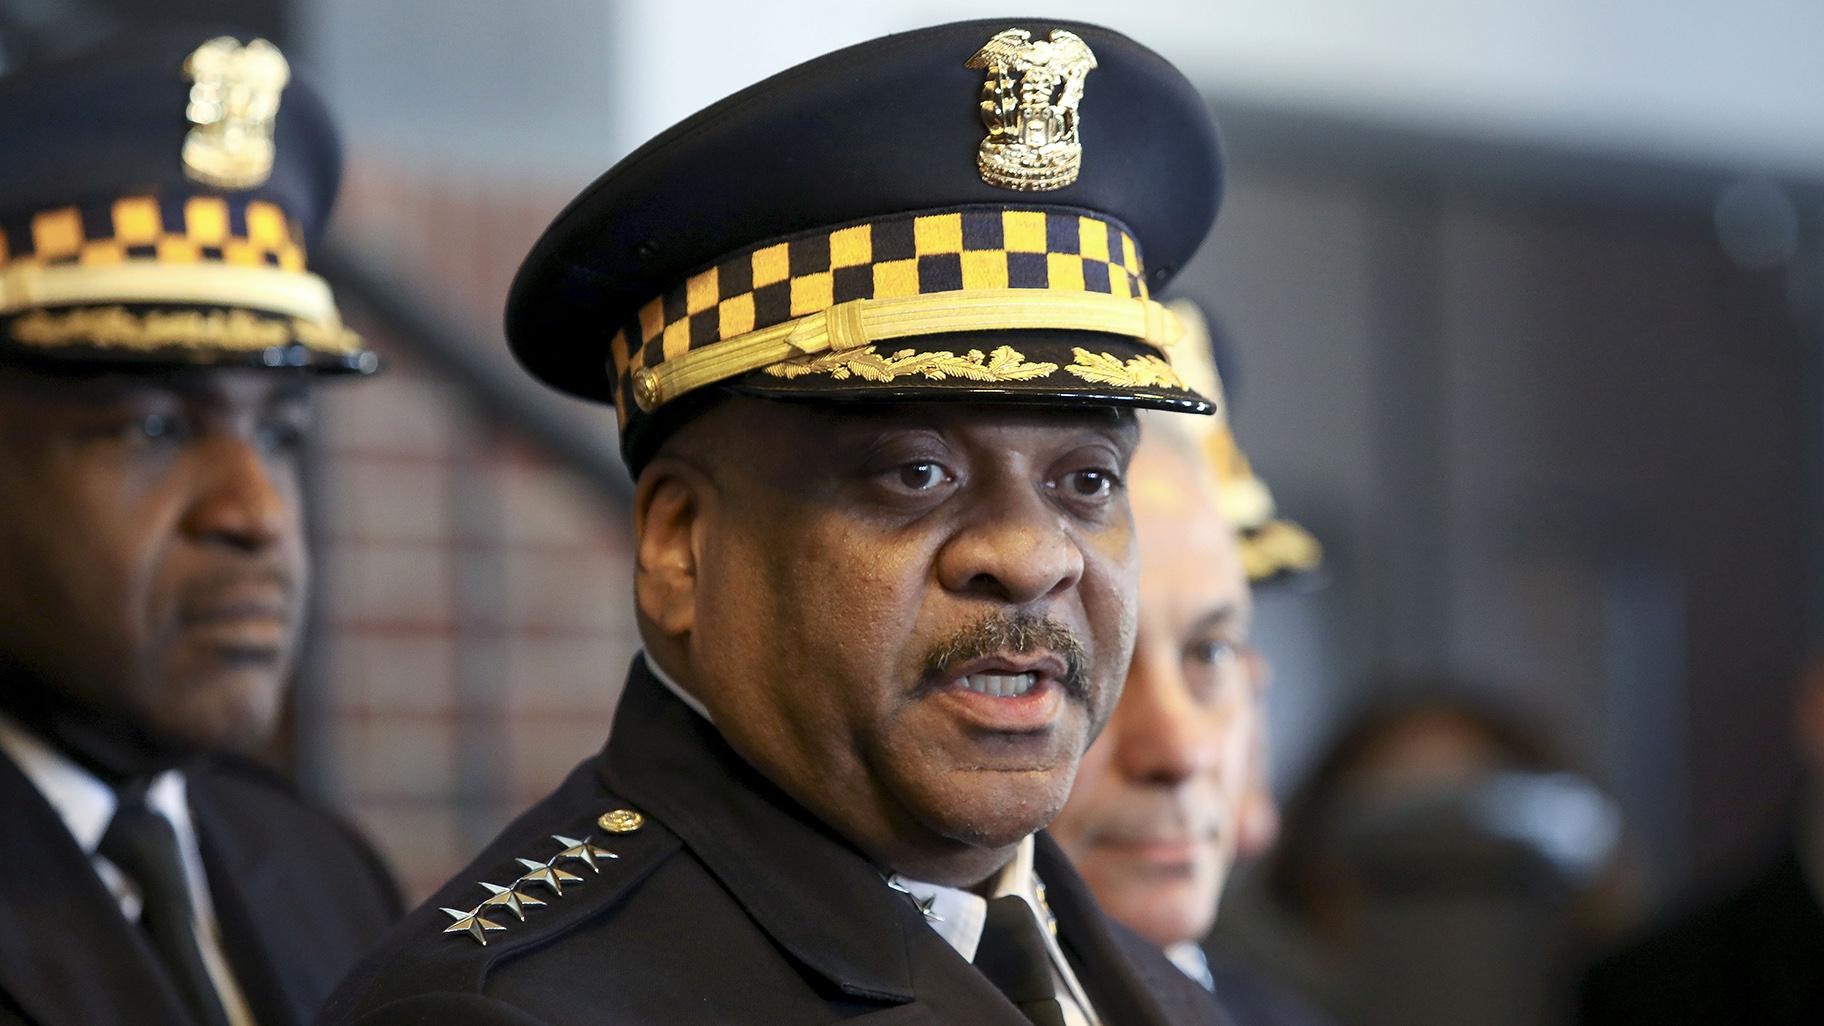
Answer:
[98, 781, 228, 1026]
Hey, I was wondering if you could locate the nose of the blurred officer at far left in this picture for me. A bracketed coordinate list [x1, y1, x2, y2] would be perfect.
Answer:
[184, 433, 294, 551]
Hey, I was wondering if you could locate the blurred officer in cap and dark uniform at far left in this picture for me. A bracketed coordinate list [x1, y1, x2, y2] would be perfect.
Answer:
[0, 33, 398, 1026]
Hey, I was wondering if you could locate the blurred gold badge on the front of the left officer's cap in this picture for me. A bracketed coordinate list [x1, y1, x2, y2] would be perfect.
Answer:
[184, 37, 292, 188]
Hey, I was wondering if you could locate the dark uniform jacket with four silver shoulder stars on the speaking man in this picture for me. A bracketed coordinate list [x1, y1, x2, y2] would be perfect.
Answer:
[325, 661, 1222, 1026]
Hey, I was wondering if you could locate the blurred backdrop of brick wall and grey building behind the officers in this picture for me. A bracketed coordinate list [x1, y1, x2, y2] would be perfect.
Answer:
[0, 0, 1824, 1015]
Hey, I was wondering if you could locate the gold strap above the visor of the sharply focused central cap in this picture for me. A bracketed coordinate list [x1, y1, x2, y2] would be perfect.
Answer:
[633, 288, 1184, 413]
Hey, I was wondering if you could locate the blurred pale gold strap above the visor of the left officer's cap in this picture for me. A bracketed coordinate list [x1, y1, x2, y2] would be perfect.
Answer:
[0, 261, 341, 330]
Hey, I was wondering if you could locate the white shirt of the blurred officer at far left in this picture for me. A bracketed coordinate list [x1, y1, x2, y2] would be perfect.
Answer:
[0, 716, 257, 1026]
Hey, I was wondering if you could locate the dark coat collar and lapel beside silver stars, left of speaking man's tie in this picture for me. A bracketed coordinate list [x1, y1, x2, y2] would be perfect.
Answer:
[602, 659, 925, 1002]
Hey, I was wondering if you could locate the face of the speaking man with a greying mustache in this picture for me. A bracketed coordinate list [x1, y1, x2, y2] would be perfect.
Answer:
[656, 400, 1138, 885]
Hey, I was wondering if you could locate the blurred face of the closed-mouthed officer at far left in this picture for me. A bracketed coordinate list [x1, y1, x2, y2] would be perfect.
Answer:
[0, 369, 310, 749]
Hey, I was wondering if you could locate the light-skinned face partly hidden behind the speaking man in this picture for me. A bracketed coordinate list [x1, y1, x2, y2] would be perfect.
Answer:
[1051, 438, 1262, 946]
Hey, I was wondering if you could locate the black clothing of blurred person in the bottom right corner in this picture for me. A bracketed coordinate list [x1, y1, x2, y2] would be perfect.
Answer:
[1581, 847, 1824, 1026]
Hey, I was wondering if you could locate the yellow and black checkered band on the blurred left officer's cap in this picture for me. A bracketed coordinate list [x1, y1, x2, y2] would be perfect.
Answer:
[0, 195, 305, 270]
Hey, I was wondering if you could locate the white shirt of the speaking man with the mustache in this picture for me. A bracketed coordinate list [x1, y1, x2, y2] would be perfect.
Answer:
[640, 652, 1102, 1026]
